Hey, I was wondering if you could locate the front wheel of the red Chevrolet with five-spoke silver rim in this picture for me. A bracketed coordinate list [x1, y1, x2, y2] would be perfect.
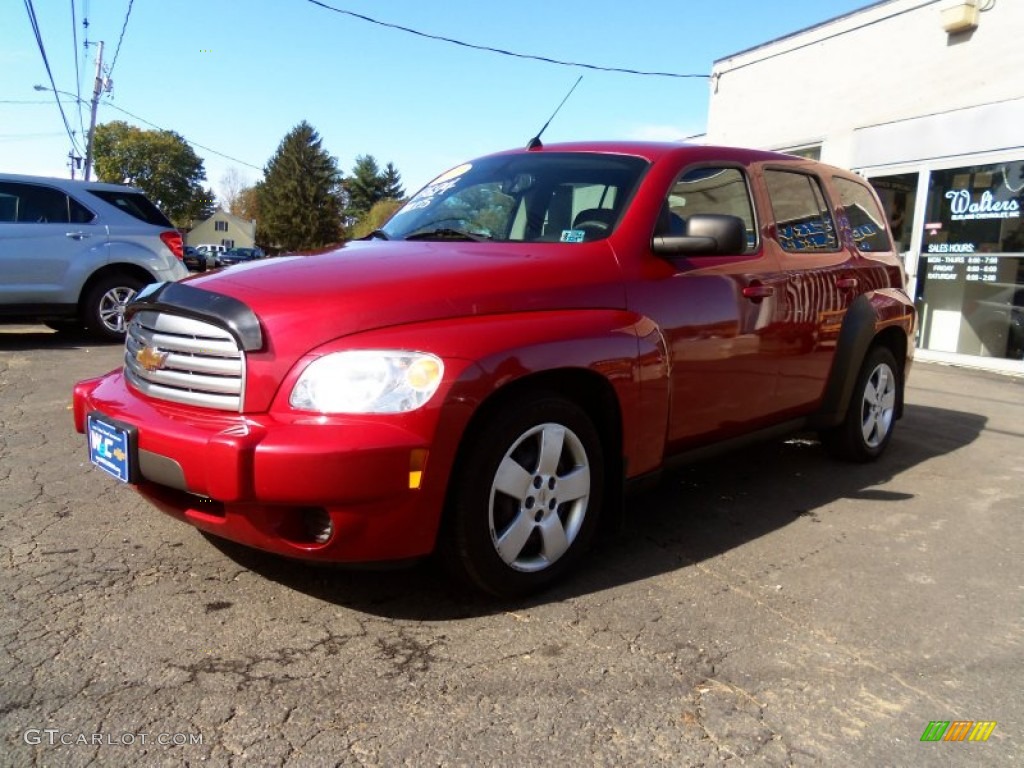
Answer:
[441, 394, 604, 597]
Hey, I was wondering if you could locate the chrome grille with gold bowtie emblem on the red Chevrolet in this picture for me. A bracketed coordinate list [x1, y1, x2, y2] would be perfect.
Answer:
[125, 311, 246, 411]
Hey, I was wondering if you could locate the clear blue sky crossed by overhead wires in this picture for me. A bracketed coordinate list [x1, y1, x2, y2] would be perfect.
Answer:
[0, 0, 871, 202]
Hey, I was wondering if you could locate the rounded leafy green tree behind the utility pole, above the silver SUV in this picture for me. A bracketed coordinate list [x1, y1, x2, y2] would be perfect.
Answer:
[92, 120, 213, 226]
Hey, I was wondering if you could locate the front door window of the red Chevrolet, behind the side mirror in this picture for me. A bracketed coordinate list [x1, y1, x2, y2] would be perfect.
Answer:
[655, 167, 758, 252]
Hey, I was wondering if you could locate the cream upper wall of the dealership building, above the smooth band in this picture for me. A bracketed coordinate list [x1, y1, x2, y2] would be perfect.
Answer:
[708, 0, 1024, 167]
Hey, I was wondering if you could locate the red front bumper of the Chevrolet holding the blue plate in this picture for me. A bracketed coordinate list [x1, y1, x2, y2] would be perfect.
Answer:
[74, 372, 450, 562]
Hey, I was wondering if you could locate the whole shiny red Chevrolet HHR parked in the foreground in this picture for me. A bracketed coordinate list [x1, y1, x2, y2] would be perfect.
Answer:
[75, 142, 914, 595]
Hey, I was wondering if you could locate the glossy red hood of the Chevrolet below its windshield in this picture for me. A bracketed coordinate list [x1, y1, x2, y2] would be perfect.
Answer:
[187, 241, 625, 410]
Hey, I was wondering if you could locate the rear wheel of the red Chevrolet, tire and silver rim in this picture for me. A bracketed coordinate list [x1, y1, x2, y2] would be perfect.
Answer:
[821, 346, 903, 463]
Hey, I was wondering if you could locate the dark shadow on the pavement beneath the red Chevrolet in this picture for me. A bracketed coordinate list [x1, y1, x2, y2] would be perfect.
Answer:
[199, 404, 986, 622]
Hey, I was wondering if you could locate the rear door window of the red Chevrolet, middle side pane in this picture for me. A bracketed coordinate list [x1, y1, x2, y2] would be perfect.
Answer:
[765, 171, 839, 253]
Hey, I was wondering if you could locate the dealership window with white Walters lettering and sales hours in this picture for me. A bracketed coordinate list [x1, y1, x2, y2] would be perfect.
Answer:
[915, 161, 1024, 359]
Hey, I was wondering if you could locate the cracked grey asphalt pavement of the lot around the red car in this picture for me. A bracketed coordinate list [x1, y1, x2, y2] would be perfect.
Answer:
[0, 326, 1024, 766]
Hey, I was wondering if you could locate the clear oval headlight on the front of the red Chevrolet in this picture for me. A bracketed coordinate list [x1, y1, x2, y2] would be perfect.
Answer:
[288, 349, 444, 414]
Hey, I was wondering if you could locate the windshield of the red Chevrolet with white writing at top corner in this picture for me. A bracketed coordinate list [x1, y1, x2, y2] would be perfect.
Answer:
[379, 153, 647, 243]
